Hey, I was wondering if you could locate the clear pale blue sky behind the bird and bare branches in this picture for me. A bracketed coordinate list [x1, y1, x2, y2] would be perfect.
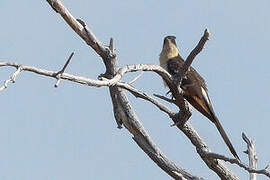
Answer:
[0, 0, 270, 180]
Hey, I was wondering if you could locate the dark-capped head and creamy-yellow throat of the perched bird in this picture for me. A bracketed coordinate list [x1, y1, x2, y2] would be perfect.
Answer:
[160, 36, 178, 59]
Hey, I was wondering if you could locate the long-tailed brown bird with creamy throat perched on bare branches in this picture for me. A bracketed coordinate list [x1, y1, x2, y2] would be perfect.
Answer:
[159, 36, 239, 160]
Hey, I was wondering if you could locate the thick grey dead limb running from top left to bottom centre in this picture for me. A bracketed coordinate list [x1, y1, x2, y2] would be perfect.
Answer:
[43, 0, 198, 179]
